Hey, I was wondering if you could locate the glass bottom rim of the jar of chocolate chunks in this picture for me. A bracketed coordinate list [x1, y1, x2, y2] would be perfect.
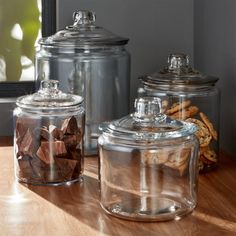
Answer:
[17, 176, 84, 186]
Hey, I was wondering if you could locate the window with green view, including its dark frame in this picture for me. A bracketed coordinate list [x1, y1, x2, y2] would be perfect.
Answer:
[0, 0, 56, 98]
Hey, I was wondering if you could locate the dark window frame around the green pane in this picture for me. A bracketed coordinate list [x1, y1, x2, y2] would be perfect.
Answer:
[0, 0, 56, 99]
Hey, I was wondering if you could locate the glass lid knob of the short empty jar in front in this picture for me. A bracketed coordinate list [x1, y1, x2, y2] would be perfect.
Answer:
[134, 97, 161, 119]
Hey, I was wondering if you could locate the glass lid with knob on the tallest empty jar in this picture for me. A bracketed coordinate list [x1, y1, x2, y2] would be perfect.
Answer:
[39, 11, 129, 48]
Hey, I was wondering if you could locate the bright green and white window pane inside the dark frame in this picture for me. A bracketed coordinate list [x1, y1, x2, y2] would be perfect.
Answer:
[0, 0, 41, 82]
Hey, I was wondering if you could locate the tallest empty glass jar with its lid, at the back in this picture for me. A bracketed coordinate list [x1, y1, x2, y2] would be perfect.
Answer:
[36, 11, 130, 155]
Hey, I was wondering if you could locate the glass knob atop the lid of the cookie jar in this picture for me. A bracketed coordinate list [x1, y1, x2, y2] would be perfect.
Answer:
[168, 53, 189, 70]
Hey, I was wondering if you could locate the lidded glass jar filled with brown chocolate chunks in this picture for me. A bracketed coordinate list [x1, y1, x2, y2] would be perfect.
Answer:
[14, 80, 84, 185]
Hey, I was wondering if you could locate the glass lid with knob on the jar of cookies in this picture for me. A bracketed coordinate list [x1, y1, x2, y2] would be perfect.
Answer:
[140, 53, 218, 88]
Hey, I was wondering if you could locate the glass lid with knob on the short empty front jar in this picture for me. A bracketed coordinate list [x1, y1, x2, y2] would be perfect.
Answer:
[100, 97, 197, 142]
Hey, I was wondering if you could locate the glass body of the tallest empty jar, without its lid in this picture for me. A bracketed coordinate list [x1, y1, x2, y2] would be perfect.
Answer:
[36, 46, 130, 155]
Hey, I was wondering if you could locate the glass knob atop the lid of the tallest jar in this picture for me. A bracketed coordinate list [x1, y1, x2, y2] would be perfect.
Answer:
[73, 11, 96, 26]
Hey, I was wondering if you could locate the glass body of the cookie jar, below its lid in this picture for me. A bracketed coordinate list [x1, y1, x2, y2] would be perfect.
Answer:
[141, 86, 220, 173]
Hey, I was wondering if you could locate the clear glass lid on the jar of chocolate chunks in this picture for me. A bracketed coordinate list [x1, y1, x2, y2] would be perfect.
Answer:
[16, 80, 83, 110]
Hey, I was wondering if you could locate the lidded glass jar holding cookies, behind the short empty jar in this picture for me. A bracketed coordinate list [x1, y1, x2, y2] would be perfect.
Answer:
[138, 54, 220, 173]
